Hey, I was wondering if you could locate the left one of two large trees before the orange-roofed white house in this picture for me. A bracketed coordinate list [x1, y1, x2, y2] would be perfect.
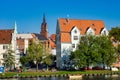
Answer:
[72, 35, 100, 67]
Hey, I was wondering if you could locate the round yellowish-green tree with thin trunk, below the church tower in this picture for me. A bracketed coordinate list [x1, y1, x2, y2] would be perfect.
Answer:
[27, 42, 48, 71]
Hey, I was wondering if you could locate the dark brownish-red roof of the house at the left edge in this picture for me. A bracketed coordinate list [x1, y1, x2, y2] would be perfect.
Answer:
[0, 29, 14, 44]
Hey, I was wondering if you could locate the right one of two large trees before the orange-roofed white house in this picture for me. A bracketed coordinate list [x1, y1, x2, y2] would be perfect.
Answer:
[98, 36, 117, 68]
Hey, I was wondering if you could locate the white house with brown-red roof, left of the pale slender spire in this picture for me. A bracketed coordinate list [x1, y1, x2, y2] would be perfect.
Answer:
[0, 29, 14, 65]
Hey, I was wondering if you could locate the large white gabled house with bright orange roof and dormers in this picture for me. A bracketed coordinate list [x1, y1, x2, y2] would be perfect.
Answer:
[56, 18, 108, 69]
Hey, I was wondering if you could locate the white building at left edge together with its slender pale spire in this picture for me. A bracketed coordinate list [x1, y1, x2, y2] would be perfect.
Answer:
[0, 22, 20, 67]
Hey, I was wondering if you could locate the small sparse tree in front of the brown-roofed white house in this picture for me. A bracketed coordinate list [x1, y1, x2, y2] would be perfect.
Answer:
[3, 48, 15, 70]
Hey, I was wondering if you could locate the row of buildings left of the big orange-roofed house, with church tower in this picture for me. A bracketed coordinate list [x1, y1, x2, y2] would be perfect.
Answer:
[0, 15, 56, 67]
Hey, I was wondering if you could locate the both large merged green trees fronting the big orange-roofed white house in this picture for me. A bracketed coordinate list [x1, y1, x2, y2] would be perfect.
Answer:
[71, 35, 116, 67]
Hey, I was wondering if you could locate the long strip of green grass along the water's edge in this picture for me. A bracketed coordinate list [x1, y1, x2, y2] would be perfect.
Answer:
[0, 70, 120, 77]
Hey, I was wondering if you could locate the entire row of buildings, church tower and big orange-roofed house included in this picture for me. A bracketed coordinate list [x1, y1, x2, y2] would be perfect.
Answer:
[0, 15, 118, 69]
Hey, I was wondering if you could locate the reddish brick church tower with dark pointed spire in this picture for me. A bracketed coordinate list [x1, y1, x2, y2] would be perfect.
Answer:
[40, 14, 48, 38]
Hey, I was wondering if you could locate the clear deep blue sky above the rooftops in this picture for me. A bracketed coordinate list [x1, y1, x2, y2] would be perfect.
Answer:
[0, 0, 120, 34]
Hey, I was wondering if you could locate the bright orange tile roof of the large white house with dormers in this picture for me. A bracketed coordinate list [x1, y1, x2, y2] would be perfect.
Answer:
[58, 18, 105, 42]
